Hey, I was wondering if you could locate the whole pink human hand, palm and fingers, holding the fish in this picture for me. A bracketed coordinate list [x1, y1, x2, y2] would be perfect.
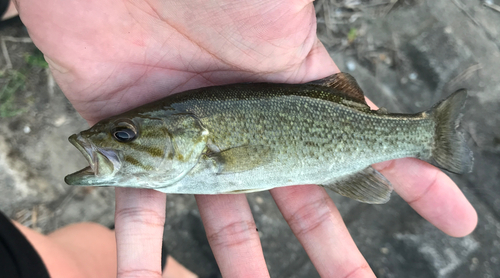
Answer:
[18, 0, 477, 277]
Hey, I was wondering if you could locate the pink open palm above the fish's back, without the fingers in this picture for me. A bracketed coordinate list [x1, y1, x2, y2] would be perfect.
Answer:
[20, 0, 335, 122]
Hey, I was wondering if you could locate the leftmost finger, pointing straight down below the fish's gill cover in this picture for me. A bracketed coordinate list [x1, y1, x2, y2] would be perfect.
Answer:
[115, 187, 166, 278]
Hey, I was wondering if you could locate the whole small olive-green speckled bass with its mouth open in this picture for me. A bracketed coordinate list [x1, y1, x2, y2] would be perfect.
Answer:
[65, 72, 473, 204]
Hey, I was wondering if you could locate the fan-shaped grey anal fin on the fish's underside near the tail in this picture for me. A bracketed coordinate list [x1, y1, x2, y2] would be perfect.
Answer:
[321, 166, 393, 204]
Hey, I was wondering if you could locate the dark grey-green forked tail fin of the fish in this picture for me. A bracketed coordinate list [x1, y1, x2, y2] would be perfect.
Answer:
[429, 89, 474, 174]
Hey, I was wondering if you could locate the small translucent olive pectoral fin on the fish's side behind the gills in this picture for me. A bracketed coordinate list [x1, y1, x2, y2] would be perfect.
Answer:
[207, 145, 271, 174]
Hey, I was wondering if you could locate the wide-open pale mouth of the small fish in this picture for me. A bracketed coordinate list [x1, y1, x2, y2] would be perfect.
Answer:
[64, 134, 121, 185]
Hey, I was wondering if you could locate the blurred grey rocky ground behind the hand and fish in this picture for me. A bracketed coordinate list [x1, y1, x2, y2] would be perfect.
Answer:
[0, 0, 500, 278]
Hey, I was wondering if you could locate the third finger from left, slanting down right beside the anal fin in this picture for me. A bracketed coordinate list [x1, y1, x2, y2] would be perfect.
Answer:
[270, 185, 375, 278]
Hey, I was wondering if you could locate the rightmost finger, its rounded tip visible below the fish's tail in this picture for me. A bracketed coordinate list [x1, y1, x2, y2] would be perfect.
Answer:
[373, 158, 477, 237]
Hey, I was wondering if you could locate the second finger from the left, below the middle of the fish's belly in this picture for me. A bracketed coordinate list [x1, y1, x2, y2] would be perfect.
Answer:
[195, 194, 269, 277]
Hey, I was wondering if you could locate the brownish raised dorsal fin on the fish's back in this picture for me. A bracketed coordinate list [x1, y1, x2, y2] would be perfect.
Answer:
[307, 72, 367, 105]
